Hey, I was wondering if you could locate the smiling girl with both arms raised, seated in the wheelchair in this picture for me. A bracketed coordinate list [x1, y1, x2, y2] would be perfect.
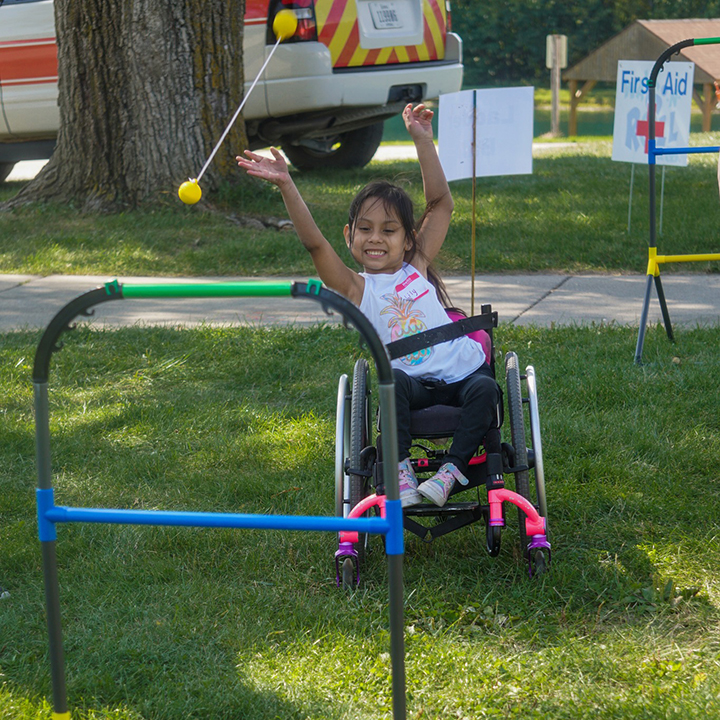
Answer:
[237, 104, 500, 507]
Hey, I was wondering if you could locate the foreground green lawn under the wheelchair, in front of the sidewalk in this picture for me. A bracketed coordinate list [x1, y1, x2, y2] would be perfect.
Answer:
[0, 324, 720, 720]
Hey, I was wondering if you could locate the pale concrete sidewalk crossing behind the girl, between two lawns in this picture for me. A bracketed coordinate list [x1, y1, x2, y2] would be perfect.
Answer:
[0, 275, 720, 332]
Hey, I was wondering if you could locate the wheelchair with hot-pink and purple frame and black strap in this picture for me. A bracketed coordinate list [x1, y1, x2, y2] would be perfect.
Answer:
[335, 305, 550, 589]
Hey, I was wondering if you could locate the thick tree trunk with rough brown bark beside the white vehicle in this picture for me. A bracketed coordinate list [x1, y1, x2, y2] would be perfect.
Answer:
[4, 0, 247, 211]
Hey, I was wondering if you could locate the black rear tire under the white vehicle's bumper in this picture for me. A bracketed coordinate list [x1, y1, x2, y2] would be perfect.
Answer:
[282, 122, 384, 170]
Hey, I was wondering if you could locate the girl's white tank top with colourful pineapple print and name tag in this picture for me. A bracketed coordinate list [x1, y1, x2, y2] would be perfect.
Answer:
[360, 263, 485, 383]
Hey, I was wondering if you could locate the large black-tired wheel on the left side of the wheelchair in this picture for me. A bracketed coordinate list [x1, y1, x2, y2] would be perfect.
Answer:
[347, 358, 372, 561]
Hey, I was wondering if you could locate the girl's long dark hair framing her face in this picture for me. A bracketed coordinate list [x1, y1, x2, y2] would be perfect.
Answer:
[348, 180, 452, 308]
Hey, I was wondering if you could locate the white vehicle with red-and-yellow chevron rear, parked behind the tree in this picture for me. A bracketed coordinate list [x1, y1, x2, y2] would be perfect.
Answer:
[0, 0, 463, 181]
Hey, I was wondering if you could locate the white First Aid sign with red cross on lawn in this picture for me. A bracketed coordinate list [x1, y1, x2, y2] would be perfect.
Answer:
[612, 60, 695, 166]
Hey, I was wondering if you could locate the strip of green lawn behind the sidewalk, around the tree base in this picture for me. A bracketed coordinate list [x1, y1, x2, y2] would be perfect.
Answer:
[0, 133, 720, 277]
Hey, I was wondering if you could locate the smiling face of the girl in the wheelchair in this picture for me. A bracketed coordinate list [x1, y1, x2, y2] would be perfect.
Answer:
[344, 197, 412, 275]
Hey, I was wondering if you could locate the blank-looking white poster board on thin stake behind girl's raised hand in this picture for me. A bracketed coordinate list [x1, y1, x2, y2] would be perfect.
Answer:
[438, 87, 535, 181]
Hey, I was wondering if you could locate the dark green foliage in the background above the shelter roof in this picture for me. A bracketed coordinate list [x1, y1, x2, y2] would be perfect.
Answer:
[452, 0, 720, 87]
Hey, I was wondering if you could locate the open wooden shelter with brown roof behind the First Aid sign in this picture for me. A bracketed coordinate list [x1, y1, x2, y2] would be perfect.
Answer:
[562, 18, 720, 135]
